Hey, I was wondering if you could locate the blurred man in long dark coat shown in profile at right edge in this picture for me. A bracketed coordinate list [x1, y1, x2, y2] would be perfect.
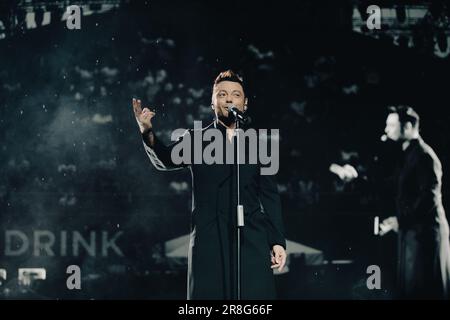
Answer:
[381, 106, 450, 299]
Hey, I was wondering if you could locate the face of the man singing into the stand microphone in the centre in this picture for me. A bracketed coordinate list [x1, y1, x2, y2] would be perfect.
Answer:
[212, 81, 247, 118]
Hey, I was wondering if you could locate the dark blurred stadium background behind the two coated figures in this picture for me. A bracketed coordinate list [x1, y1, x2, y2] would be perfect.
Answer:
[0, 0, 450, 299]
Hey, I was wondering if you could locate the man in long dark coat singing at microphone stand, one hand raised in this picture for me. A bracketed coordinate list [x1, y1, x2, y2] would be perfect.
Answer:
[133, 70, 286, 299]
